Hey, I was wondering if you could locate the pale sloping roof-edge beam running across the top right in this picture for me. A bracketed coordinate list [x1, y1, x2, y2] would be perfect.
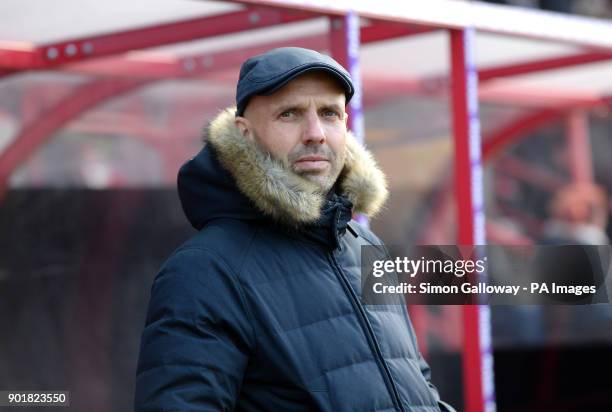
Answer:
[233, 0, 612, 49]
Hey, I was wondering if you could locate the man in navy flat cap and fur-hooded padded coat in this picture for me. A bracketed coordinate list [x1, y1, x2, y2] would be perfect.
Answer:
[135, 47, 452, 412]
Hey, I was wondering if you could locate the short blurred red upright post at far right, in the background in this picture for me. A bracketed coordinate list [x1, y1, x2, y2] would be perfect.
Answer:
[566, 109, 593, 183]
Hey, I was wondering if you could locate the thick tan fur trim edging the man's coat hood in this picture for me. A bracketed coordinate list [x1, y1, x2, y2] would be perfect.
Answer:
[208, 107, 388, 226]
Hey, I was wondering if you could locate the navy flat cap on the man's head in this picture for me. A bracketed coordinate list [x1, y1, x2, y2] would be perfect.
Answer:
[236, 47, 355, 116]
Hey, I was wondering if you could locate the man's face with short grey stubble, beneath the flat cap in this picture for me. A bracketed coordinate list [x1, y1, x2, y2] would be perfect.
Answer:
[236, 72, 348, 193]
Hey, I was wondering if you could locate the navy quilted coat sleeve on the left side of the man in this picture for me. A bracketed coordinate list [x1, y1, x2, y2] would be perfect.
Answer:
[134, 249, 254, 412]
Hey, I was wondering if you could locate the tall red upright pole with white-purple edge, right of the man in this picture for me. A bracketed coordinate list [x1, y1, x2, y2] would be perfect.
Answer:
[450, 29, 495, 412]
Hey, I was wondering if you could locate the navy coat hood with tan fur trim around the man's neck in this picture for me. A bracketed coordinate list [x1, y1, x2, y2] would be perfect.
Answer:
[178, 108, 388, 229]
